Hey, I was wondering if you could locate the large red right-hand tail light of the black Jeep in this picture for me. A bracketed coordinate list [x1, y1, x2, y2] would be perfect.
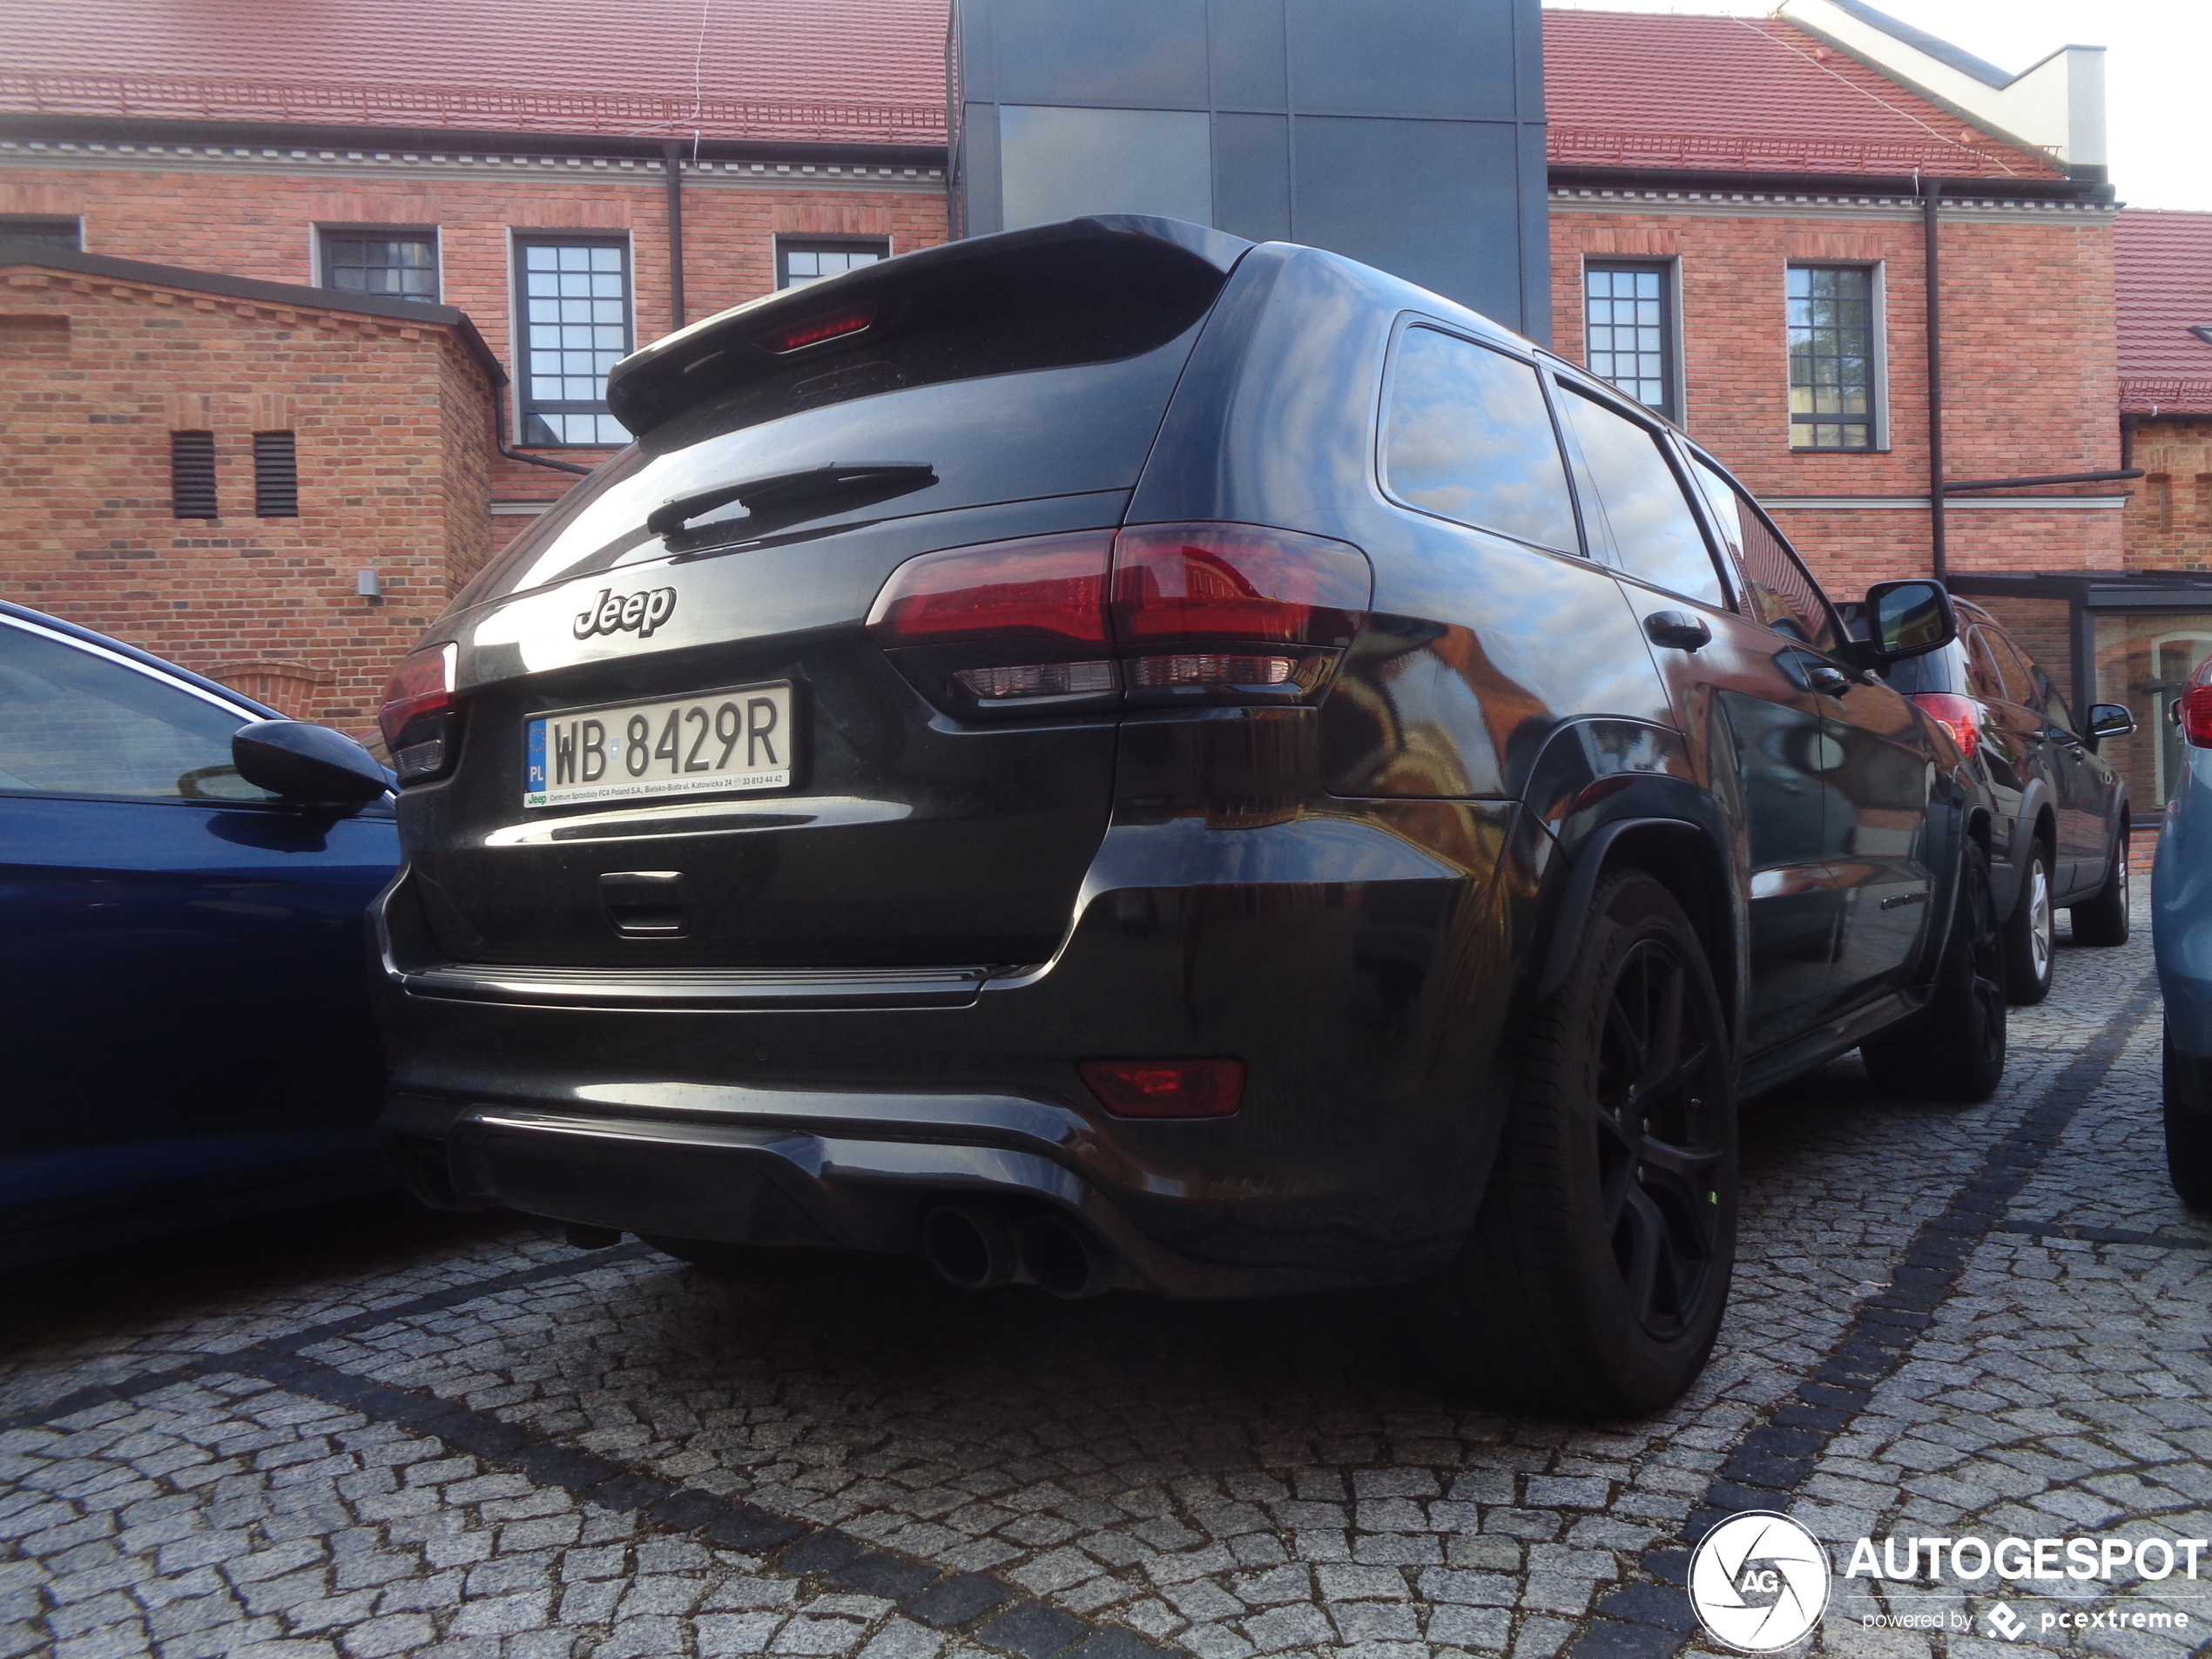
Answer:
[867, 524, 1373, 714]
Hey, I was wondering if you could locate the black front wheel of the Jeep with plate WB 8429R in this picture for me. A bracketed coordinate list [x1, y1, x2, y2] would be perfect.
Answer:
[1858, 840, 2004, 1106]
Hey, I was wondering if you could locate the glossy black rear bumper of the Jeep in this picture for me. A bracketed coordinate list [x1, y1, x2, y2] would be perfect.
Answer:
[376, 803, 1513, 1296]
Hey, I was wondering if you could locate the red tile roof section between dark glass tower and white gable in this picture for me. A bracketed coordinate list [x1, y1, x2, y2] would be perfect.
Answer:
[1544, 11, 2061, 179]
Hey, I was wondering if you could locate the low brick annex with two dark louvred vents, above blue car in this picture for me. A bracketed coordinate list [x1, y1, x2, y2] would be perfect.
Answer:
[0, 247, 504, 725]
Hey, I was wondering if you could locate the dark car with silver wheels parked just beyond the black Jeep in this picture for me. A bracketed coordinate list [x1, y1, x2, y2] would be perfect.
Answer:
[1887, 599, 2134, 1002]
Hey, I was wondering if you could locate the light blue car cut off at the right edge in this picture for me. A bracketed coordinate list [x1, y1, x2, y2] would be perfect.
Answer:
[2150, 657, 2212, 1210]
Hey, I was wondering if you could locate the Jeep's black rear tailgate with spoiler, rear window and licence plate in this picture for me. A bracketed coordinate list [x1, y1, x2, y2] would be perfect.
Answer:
[394, 221, 1234, 969]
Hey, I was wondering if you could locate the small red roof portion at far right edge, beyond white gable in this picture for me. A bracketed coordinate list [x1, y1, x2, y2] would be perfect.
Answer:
[2113, 208, 2212, 414]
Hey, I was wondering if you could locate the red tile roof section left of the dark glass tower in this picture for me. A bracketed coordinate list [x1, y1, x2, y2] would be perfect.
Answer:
[0, 0, 947, 144]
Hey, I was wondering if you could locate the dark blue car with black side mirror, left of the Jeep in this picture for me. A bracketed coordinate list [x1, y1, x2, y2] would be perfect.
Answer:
[0, 604, 398, 1265]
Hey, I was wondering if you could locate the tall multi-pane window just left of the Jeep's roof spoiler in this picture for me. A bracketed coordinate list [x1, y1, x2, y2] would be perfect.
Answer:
[516, 241, 631, 445]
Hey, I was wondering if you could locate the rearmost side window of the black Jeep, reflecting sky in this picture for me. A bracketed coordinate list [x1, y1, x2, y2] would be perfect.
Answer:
[1383, 327, 1581, 553]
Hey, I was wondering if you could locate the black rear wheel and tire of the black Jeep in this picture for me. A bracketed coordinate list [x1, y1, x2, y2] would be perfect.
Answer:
[1416, 869, 1737, 1420]
